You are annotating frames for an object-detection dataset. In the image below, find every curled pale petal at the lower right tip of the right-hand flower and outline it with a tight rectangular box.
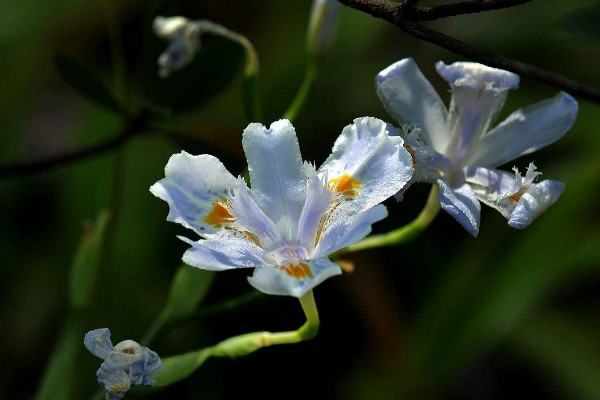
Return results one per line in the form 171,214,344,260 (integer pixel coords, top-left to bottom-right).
508,180,565,229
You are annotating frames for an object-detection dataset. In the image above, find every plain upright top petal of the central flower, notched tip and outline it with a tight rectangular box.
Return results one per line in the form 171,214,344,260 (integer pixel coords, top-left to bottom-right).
242,120,306,224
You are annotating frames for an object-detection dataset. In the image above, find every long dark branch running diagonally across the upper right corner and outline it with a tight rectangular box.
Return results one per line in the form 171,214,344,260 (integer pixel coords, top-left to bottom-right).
339,0,600,103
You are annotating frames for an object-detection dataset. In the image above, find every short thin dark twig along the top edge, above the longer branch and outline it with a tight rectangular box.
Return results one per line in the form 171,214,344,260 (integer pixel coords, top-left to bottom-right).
410,0,531,21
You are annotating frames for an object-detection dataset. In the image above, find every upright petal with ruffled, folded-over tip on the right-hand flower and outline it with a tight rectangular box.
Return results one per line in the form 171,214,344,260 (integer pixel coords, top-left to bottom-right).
435,61,519,165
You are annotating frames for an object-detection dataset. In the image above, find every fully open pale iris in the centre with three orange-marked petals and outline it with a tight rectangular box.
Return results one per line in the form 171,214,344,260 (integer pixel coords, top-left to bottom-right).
150,118,412,297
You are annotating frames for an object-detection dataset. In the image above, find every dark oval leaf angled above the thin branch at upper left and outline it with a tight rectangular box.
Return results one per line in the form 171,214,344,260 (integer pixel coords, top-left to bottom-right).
54,54,125,114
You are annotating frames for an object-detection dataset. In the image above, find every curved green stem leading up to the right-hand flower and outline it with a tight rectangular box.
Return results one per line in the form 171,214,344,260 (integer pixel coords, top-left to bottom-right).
334,185,440,257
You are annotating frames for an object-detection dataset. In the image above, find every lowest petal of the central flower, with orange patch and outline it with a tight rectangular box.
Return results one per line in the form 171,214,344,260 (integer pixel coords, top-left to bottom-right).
248,257,342,297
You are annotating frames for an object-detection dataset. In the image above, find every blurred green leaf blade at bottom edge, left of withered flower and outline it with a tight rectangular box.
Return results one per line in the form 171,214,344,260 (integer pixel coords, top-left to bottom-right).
36,317,83,400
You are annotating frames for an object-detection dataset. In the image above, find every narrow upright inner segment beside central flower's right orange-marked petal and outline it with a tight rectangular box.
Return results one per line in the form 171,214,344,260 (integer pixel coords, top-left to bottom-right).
298,176,335,251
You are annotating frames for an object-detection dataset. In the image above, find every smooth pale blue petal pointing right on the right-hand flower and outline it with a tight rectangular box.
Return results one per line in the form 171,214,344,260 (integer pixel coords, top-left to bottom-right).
466,92,578,167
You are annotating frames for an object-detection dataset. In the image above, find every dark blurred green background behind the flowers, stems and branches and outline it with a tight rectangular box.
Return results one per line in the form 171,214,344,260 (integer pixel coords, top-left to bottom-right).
0,0,600,400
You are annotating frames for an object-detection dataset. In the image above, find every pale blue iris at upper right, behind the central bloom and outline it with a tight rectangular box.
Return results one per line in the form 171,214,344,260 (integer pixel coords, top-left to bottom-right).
375,58,577,236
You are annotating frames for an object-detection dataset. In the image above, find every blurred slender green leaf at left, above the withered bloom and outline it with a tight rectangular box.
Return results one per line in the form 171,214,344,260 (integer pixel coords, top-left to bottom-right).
69,211,109,310
